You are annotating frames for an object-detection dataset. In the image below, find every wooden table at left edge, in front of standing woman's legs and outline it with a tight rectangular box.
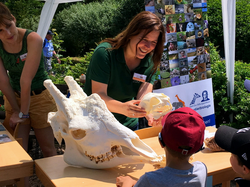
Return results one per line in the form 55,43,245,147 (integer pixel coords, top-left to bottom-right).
0,123,34,186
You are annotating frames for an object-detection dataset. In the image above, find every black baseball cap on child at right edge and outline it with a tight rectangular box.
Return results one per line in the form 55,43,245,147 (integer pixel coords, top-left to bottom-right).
215,125,250,169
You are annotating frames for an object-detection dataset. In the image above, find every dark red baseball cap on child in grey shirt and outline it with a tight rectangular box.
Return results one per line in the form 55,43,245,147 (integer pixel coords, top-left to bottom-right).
160,107,206,155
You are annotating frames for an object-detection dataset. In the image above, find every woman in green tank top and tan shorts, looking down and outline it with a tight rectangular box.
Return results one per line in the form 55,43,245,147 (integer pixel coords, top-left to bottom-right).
0,3,57,157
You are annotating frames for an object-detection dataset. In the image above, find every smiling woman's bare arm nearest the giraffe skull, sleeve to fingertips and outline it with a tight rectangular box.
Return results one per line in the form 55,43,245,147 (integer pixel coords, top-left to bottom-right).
91,80,146,118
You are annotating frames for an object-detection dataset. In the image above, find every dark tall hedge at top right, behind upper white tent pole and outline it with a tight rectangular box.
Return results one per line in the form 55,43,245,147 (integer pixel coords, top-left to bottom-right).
207,0,250,62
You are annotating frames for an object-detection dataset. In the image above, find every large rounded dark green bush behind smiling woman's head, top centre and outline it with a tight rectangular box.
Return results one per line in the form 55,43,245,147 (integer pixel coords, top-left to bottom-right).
53,0,144,56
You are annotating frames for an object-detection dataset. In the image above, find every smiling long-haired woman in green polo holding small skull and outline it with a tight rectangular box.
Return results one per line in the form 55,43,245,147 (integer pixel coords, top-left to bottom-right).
84,11,165,130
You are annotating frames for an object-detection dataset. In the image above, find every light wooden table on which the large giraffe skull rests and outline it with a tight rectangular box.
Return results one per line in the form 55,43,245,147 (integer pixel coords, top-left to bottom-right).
35,126,236,187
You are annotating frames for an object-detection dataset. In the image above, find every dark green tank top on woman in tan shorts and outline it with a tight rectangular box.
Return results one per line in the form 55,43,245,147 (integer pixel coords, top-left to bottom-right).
0,30,49,91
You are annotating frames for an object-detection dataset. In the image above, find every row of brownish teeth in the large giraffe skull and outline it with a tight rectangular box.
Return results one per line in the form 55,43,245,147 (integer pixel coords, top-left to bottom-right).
84,145,122,164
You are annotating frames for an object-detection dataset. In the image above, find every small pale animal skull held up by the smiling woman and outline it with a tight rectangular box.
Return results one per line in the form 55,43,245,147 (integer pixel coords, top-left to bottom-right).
139,92,173,119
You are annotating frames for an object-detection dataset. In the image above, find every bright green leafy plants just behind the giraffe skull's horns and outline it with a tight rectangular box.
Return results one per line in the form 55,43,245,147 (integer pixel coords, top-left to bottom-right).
50,49,94,84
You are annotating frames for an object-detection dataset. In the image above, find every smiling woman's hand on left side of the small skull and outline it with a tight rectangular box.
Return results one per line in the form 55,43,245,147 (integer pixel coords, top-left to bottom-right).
123,100,147,118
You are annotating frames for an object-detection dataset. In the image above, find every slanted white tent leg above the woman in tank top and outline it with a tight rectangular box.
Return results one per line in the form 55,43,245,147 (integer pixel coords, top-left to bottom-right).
37,0,82,39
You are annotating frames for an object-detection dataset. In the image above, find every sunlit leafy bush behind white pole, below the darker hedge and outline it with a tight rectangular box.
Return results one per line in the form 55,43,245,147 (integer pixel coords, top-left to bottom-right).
210,44,250,128
